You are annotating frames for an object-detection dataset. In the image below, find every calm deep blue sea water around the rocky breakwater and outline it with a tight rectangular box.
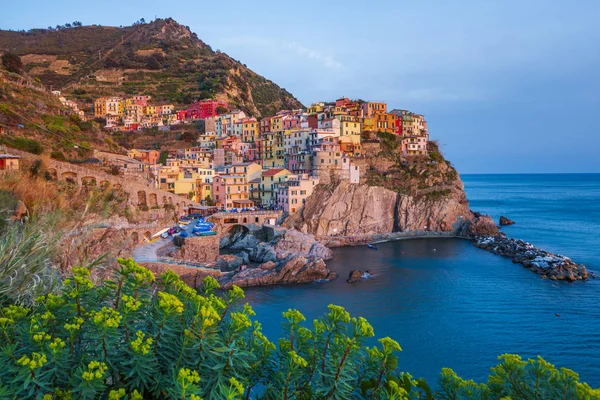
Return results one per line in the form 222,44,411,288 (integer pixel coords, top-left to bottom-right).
247,175,600,386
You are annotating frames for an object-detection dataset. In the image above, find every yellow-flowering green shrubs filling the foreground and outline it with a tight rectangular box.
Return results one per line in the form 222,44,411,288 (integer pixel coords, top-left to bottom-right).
0,255,600,400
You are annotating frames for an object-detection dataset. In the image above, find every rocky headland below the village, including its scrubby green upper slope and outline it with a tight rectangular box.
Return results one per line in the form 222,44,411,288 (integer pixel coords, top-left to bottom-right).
285,137,478,239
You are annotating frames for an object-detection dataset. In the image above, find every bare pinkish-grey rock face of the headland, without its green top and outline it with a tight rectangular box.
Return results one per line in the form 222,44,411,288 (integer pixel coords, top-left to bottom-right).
286,178,474,236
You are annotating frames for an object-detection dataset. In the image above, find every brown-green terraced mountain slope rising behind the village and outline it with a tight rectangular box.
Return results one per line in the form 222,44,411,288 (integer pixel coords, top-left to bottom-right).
0,18,302,116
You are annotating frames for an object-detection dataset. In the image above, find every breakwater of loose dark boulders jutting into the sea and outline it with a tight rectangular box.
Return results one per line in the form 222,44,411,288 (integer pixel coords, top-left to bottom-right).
474,233,596,282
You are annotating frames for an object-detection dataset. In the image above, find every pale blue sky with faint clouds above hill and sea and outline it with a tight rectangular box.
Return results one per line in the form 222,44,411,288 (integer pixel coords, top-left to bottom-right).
0,0,600,173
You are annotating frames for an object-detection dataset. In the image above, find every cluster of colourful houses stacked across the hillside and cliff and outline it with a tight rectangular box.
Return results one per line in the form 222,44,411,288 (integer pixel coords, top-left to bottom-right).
5,92,429,214
